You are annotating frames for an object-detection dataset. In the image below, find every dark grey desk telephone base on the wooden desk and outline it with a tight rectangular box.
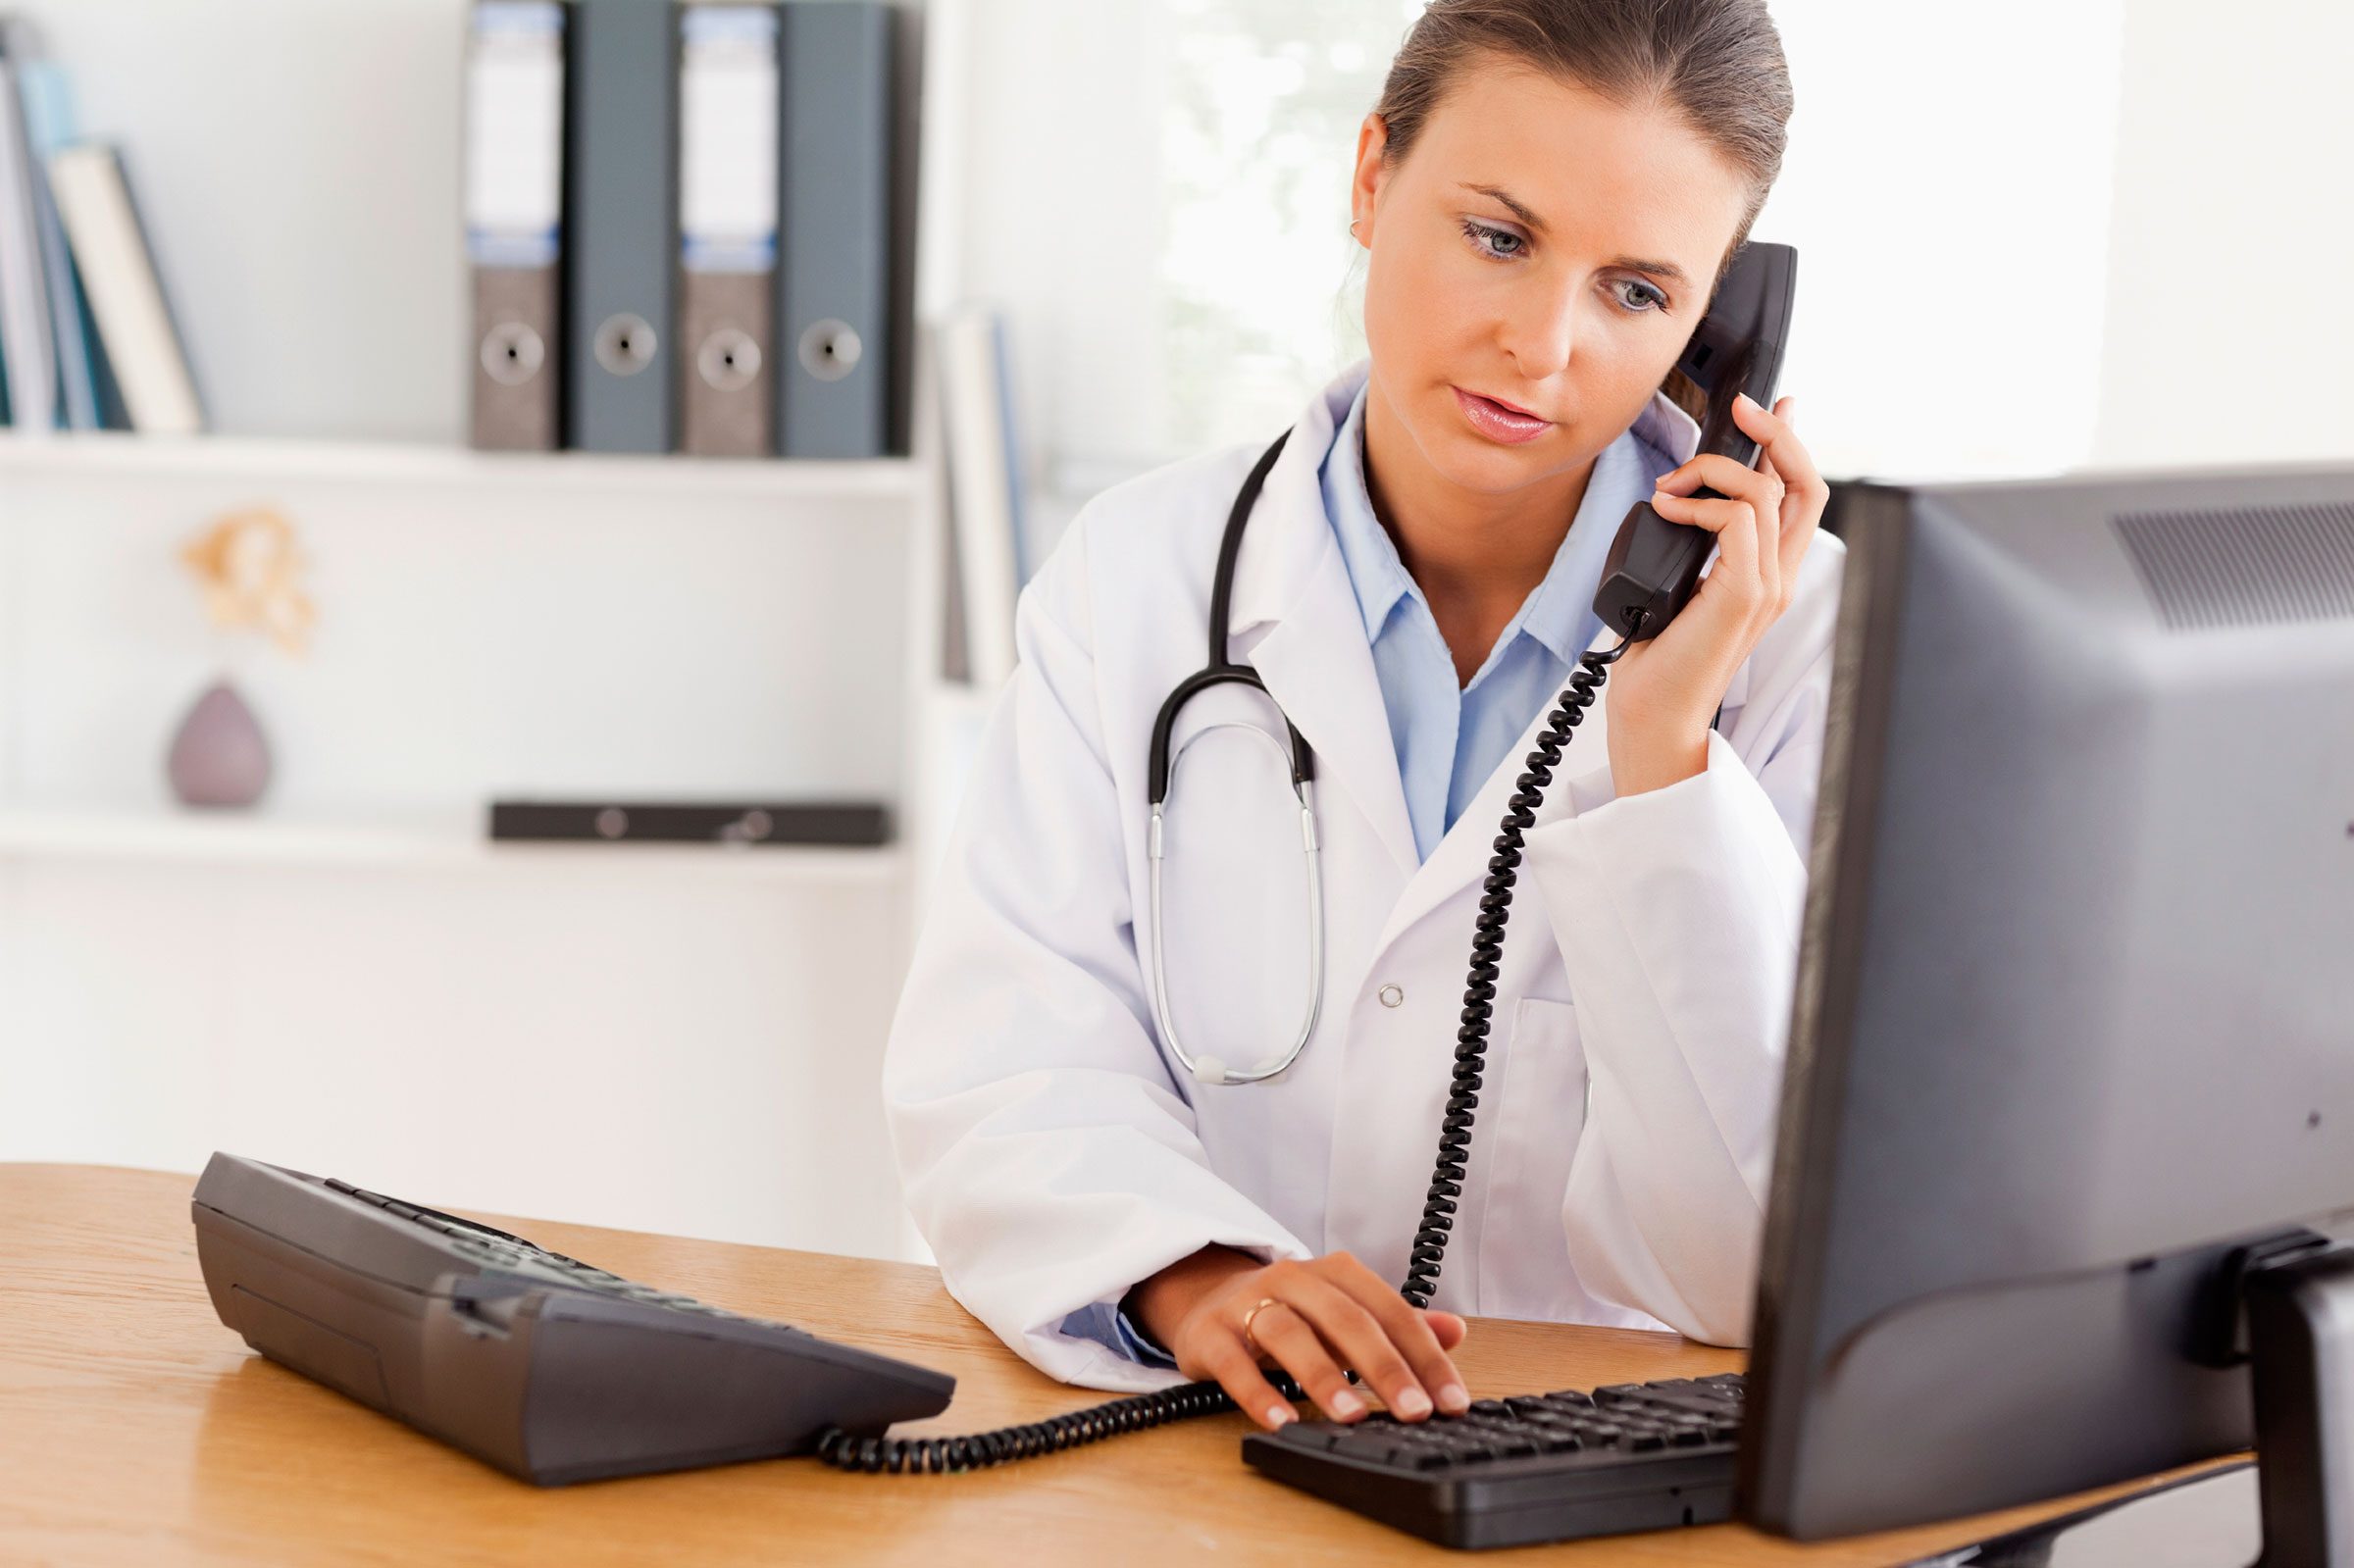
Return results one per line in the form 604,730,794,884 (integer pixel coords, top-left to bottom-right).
190,1153,955,1486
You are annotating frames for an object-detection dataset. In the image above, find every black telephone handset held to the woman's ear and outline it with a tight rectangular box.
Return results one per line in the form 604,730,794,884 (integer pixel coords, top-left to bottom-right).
1594,240,1799,642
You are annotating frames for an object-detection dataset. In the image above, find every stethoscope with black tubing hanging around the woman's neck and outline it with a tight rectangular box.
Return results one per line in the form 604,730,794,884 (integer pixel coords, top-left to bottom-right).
1144,429,1725,1086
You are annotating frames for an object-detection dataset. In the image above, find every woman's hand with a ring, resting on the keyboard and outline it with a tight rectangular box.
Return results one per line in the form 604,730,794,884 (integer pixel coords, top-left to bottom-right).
1135,1247,1471,1432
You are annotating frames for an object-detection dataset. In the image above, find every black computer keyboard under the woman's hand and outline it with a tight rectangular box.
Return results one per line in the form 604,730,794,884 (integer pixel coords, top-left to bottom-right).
1243,1373,1742,1546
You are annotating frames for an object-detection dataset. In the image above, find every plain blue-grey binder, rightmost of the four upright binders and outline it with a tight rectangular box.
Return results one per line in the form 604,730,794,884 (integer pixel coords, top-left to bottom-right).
775,0,895,457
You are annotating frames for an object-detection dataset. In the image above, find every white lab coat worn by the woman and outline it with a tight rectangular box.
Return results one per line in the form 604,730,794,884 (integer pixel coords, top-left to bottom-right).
883,360,1846,1391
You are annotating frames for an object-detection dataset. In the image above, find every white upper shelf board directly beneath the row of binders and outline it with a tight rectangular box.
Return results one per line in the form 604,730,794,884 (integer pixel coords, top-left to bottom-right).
0,430,923,501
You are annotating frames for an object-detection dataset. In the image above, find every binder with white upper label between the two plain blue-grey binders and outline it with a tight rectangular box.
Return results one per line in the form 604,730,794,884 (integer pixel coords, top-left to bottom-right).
678,0,779,457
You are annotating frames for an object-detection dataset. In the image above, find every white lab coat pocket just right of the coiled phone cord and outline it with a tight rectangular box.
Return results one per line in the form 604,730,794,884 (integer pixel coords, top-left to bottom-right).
1471,996,1587,1299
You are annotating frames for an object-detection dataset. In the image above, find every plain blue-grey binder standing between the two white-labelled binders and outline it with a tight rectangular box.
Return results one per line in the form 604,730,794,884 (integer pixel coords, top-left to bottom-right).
565,0,678,452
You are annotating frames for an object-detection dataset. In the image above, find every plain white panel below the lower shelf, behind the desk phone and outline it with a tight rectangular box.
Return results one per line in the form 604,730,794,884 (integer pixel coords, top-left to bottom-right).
0,847,911,1262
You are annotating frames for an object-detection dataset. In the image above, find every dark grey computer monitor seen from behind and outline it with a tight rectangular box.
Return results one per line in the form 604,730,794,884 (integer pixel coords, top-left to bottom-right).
1740,466,2354,1535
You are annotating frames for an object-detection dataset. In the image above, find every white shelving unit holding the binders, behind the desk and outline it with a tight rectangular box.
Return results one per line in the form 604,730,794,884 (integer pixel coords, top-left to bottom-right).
0,0,989,1257
